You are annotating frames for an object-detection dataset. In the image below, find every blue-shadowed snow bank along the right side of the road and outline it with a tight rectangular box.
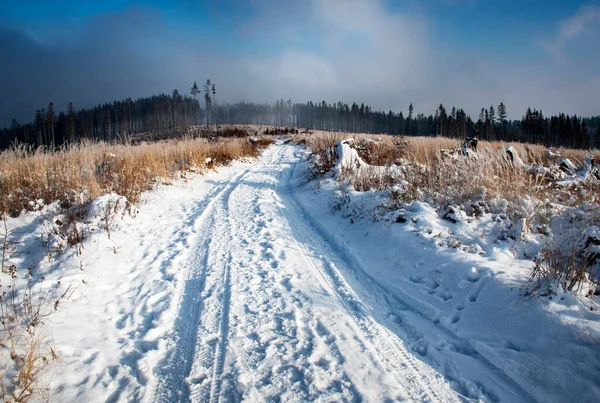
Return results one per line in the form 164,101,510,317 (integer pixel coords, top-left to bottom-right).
300,150,600,402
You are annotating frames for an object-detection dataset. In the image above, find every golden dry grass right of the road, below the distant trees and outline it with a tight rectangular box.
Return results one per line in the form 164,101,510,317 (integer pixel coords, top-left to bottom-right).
296,132,600,207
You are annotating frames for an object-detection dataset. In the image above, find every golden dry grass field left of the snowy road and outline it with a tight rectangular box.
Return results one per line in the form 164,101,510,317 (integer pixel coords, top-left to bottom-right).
0,138,271,216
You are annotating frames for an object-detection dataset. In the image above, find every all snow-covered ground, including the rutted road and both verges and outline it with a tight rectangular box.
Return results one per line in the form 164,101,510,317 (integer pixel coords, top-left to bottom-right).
1,142,600,402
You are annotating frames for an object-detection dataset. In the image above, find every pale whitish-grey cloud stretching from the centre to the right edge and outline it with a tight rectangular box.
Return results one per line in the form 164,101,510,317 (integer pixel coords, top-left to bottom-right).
234,0,600,118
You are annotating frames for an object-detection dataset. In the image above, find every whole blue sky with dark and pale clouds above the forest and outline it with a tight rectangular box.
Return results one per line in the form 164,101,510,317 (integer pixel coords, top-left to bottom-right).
0,0,600,126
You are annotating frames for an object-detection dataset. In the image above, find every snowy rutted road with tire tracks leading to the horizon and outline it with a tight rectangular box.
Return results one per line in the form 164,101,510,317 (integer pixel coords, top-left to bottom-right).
145,145,460,402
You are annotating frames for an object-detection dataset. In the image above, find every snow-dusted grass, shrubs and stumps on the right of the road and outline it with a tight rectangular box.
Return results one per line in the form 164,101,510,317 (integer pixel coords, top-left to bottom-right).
308,134,600,295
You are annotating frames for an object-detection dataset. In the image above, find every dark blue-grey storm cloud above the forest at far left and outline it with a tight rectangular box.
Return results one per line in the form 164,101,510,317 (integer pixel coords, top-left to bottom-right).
0,10,176,125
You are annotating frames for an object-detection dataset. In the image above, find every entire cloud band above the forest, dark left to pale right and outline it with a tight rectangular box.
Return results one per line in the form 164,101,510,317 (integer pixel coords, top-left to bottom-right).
0,0,600,125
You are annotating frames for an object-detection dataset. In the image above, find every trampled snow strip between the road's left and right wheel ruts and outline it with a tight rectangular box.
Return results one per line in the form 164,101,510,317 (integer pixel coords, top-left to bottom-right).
224,147,364,401
